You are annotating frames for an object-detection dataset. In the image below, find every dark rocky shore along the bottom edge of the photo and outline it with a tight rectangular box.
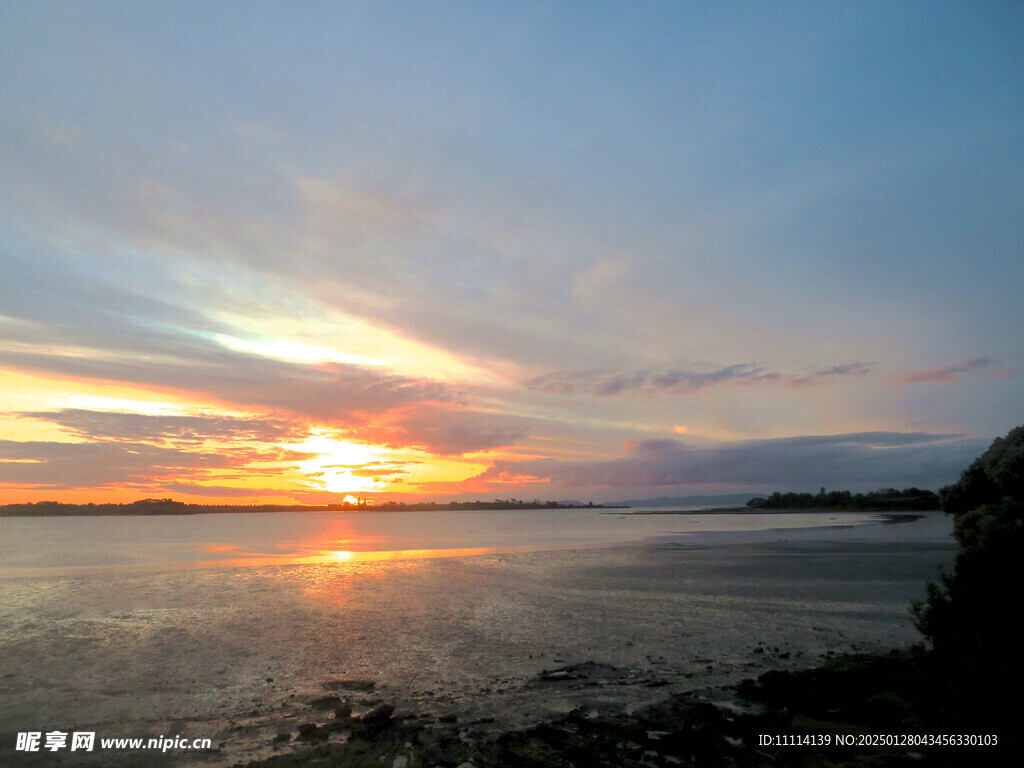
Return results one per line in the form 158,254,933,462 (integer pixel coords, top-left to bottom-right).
230,650,991,768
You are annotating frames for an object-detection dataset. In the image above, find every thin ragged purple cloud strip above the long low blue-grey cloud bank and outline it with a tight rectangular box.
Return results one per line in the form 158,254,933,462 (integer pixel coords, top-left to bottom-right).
524,362,876,397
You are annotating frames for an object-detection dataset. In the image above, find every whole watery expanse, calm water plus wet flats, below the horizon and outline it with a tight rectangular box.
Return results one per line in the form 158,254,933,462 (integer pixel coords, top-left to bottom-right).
0,510,954,768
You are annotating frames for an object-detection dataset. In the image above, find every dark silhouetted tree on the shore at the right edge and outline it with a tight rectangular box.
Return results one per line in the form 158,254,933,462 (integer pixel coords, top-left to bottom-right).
914,426,1024,735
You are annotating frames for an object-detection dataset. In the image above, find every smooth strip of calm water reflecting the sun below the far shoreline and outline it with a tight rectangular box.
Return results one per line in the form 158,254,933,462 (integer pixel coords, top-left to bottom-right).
0,509,878,575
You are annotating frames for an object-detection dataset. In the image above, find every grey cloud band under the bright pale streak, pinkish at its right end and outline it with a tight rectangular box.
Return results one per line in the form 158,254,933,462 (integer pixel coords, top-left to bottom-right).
0,243,457,423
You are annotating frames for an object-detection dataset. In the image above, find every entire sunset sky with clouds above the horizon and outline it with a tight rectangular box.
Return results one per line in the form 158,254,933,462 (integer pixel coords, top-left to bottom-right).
0,0,1024,504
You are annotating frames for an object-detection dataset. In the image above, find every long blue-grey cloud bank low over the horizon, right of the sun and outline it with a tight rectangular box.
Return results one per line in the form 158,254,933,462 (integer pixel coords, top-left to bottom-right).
464,432,984,490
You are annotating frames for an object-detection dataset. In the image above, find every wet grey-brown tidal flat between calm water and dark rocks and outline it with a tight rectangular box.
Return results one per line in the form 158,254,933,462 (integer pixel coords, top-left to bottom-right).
0,514,954,765
